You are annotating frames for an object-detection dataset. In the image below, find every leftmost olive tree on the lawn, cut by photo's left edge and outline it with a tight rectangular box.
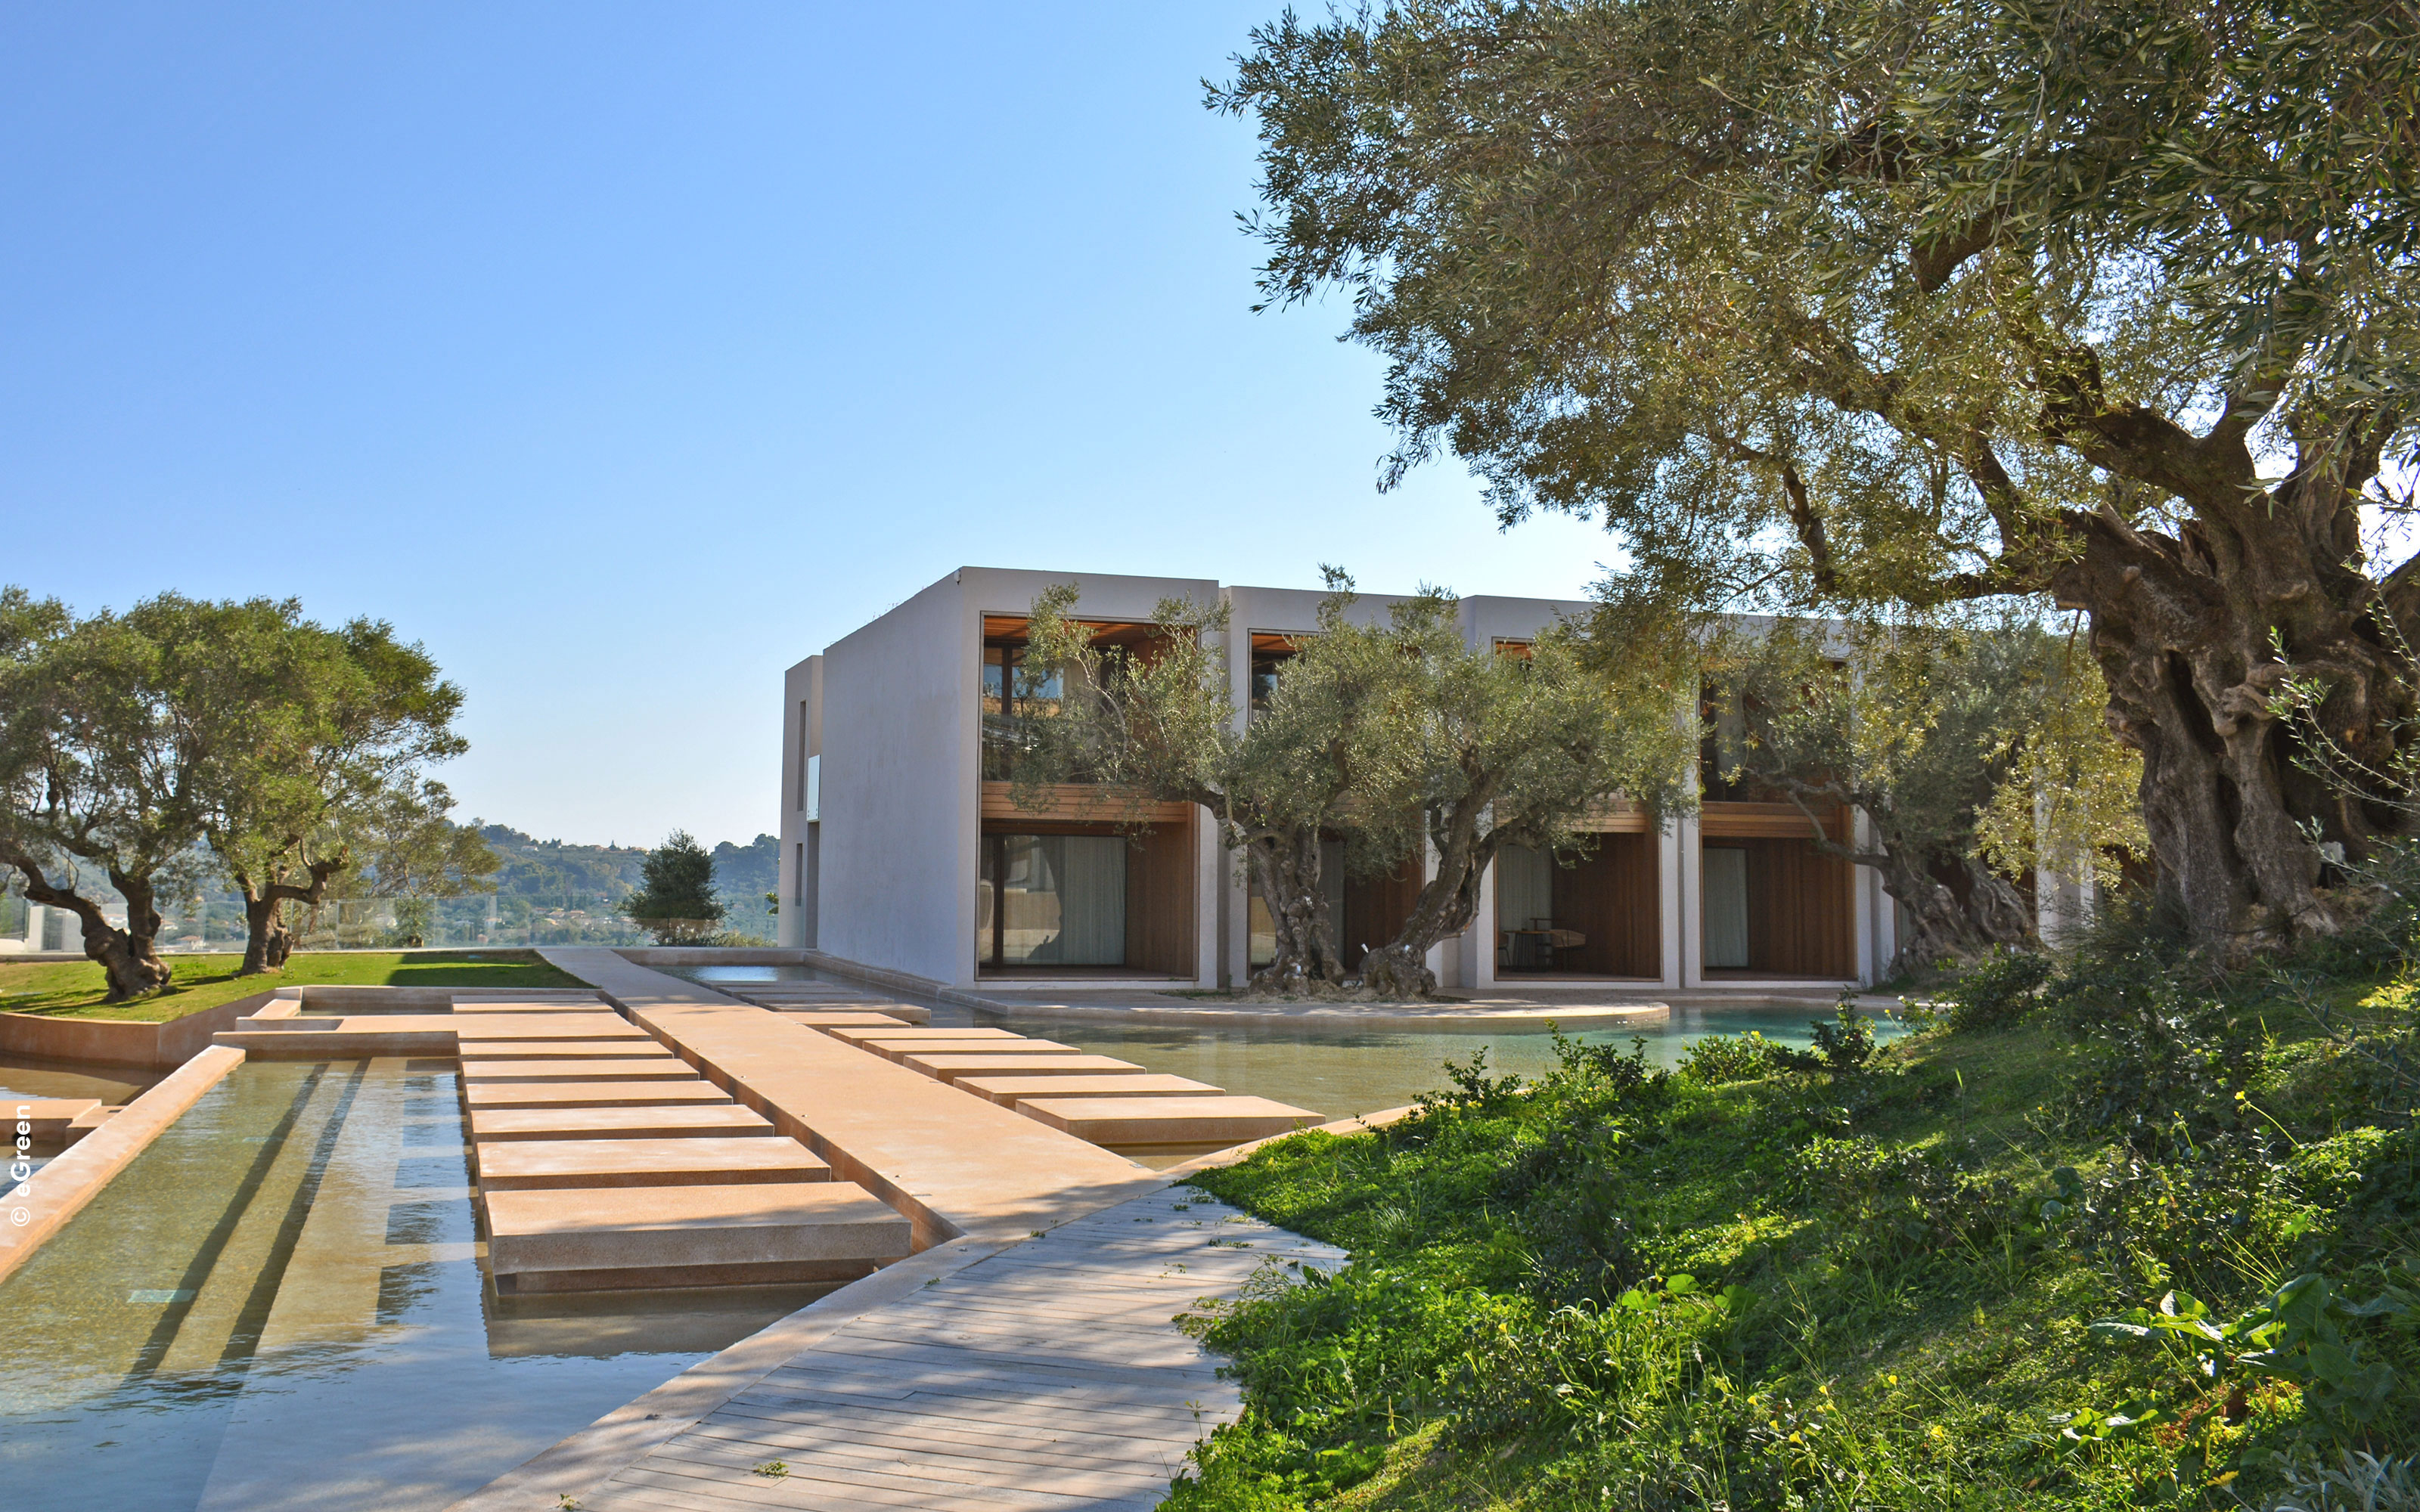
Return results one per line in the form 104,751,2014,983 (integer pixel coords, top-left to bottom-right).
0,588,250,1002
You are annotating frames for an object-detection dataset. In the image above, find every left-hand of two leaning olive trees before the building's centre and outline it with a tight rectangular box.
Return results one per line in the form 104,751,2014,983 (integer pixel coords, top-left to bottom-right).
1012,569,1401,994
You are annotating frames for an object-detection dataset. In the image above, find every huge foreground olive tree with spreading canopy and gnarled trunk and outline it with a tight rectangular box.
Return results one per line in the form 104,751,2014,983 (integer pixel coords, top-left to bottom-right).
1212,0,2420,958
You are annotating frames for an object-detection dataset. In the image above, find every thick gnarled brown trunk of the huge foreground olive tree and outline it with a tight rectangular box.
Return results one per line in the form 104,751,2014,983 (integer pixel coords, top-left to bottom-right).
2049,404,2420,963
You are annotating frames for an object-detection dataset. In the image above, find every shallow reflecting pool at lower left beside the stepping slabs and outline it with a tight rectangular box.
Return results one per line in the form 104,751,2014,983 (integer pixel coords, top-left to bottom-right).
0,1057,818,1512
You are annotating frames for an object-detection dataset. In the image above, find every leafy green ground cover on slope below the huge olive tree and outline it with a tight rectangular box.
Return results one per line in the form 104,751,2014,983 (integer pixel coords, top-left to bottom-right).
1169,914,2420,1512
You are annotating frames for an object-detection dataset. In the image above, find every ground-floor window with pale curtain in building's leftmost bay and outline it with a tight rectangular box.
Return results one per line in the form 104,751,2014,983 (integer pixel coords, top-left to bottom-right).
976,835,1128,970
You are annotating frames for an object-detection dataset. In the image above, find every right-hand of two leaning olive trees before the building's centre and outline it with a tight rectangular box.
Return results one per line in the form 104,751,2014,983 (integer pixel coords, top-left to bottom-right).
1339,588,1692,996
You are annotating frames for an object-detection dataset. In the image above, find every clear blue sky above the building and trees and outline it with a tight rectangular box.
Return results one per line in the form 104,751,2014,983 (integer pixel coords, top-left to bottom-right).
0,0,1612,844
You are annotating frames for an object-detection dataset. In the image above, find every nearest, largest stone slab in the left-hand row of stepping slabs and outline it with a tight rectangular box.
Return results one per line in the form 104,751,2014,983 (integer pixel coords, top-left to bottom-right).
486,1181,910,1294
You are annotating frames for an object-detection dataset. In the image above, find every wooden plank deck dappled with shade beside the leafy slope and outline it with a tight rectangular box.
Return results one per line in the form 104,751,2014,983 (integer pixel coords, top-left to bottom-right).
576,1185,1343,1512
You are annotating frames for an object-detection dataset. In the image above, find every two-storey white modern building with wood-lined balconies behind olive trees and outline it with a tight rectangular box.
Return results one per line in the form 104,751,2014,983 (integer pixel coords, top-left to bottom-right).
779,566,1895,992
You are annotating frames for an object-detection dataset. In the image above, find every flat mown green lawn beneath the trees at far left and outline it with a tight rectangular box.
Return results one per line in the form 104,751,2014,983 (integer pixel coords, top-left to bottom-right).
0,951,585,1024
